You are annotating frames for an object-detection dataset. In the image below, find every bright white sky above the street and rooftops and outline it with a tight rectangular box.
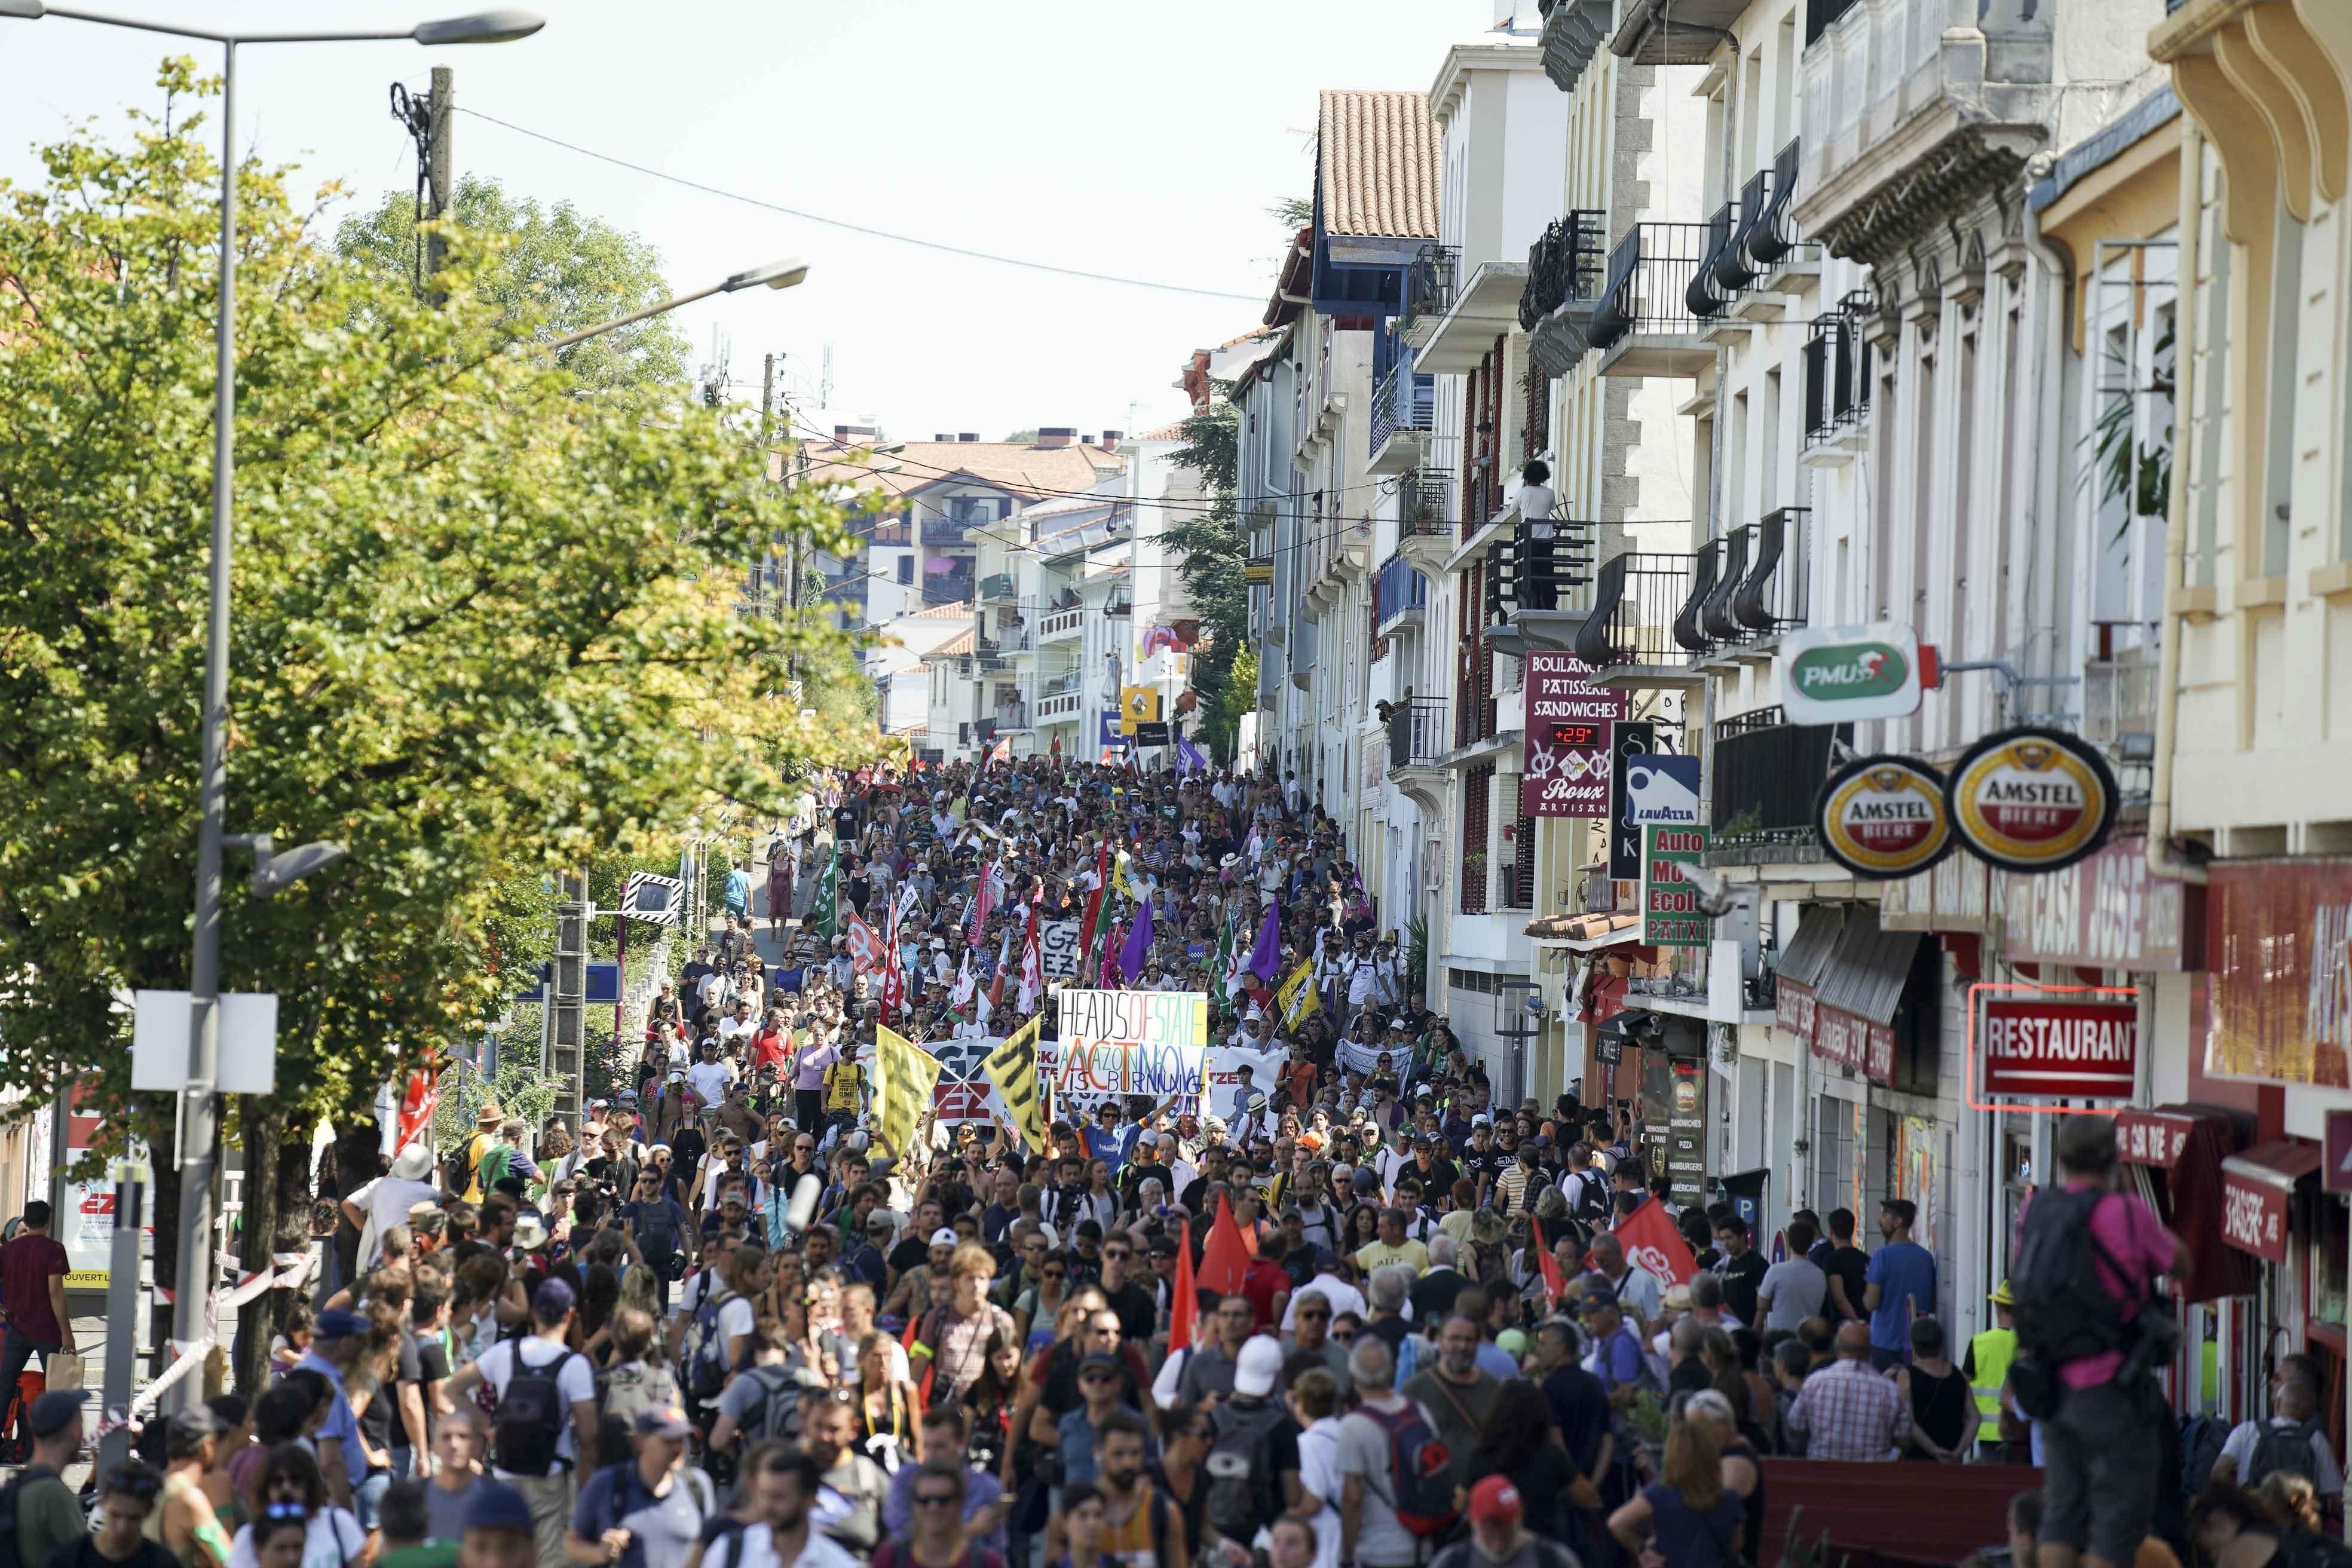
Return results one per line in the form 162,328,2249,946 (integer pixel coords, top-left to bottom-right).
0,0,1493,440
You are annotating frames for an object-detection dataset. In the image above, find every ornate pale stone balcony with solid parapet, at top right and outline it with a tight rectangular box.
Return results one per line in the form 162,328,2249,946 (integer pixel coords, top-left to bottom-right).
1792,0,2060,261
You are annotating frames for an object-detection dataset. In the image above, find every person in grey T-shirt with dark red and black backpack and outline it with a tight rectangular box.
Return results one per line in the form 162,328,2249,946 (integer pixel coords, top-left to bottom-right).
1339,1336,1456,1568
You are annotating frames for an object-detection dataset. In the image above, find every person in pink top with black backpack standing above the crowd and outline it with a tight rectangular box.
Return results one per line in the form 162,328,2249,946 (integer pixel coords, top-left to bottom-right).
2011,1117,2187,1568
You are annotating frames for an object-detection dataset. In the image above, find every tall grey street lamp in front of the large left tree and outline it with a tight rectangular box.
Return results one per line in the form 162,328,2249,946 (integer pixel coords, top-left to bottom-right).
0,0,546,1408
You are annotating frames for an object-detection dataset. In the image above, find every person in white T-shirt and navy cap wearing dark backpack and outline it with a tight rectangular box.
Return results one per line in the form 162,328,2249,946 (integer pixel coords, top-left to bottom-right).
449,1279,598,1568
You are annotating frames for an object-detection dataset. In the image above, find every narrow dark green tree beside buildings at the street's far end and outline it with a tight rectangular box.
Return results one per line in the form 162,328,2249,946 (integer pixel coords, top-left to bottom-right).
1166,383,1256,757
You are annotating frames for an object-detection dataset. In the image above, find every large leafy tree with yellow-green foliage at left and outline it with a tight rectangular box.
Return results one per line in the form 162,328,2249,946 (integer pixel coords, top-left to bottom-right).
0,61,880,1380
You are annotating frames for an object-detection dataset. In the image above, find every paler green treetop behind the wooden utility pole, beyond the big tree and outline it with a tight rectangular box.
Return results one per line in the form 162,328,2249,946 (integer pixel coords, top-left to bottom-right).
334,174,687,390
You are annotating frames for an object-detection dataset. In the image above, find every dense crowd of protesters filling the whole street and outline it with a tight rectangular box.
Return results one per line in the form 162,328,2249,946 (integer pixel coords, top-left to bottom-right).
0,760,2340,1568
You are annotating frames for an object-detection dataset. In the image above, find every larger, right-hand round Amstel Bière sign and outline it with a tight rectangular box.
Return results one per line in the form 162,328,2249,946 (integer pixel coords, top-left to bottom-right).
1945,729,2114,874
